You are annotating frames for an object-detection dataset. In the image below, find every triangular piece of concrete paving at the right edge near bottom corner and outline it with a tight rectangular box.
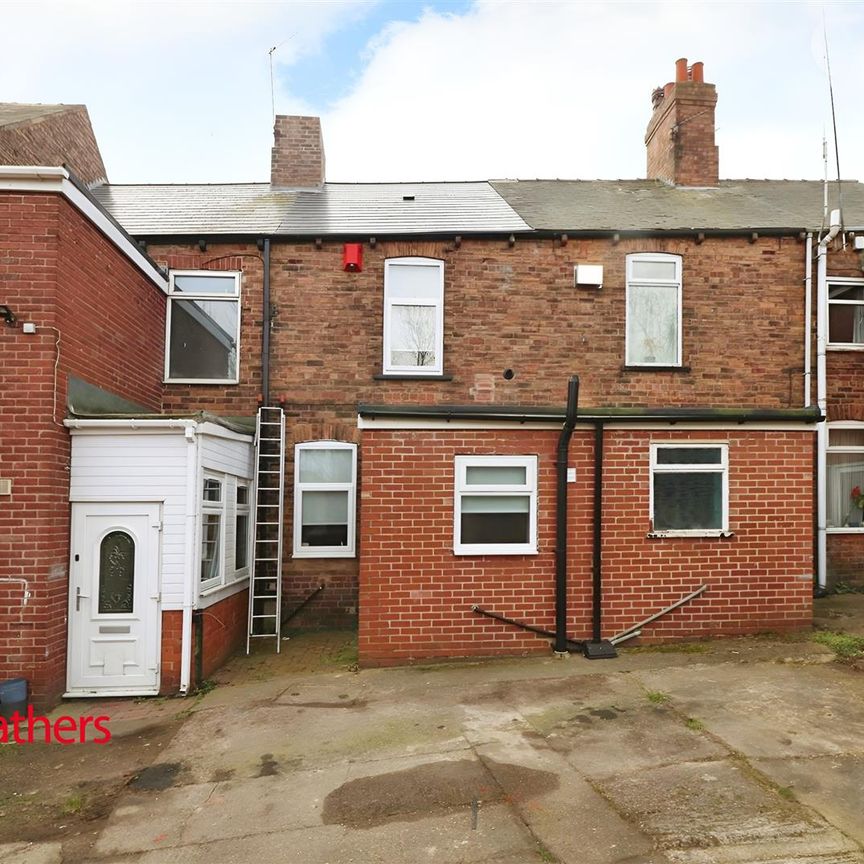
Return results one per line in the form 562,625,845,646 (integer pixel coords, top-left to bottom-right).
753,756,864,846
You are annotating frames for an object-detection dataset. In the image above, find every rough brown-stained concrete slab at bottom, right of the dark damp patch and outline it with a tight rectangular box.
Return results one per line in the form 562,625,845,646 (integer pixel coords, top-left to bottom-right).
600,760,860,864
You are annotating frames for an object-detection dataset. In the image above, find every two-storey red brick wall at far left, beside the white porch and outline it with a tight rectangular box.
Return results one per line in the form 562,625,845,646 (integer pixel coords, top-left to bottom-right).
0,193,164,704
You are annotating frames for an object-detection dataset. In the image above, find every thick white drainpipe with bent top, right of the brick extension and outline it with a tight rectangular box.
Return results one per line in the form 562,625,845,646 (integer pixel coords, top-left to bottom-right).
816,210,840,588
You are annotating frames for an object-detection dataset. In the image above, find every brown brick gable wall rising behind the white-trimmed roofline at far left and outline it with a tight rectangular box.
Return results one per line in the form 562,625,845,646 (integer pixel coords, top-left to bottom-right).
0,105,105,185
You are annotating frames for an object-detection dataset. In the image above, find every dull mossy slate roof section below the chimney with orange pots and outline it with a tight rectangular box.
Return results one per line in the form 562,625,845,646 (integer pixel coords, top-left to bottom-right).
492,180,864,232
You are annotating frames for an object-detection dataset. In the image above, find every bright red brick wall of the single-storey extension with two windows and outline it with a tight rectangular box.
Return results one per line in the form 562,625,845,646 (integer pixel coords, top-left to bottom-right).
360,427,813,663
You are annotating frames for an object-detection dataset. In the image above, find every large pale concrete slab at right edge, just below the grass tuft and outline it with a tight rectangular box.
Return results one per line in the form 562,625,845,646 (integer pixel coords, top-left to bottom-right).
639,663,864,758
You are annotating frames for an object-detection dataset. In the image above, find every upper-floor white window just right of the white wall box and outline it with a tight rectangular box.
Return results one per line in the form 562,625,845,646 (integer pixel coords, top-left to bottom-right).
625,252,681,366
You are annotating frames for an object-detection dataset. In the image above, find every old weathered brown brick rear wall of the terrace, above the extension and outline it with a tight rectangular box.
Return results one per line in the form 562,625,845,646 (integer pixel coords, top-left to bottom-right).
142,231,804,626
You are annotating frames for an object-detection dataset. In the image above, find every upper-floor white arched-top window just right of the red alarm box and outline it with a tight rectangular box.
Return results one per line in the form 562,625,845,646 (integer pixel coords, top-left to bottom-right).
383,258,444,375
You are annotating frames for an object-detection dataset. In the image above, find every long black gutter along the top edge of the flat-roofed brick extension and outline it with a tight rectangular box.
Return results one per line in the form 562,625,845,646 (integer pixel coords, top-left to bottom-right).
357,403,825,425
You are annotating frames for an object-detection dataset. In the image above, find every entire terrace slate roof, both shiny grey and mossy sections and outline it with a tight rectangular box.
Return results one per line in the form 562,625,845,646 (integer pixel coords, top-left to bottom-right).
92,180,864,237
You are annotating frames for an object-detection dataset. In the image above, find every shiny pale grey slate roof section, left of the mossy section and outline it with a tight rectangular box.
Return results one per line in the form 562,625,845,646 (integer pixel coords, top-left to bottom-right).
92,182,530,237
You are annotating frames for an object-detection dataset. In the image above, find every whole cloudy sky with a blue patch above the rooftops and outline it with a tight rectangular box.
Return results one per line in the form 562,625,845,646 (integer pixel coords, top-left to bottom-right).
0,0,864,183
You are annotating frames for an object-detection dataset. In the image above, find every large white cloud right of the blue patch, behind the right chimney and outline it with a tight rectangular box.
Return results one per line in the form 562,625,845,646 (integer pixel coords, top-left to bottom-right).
324,0,864,180
